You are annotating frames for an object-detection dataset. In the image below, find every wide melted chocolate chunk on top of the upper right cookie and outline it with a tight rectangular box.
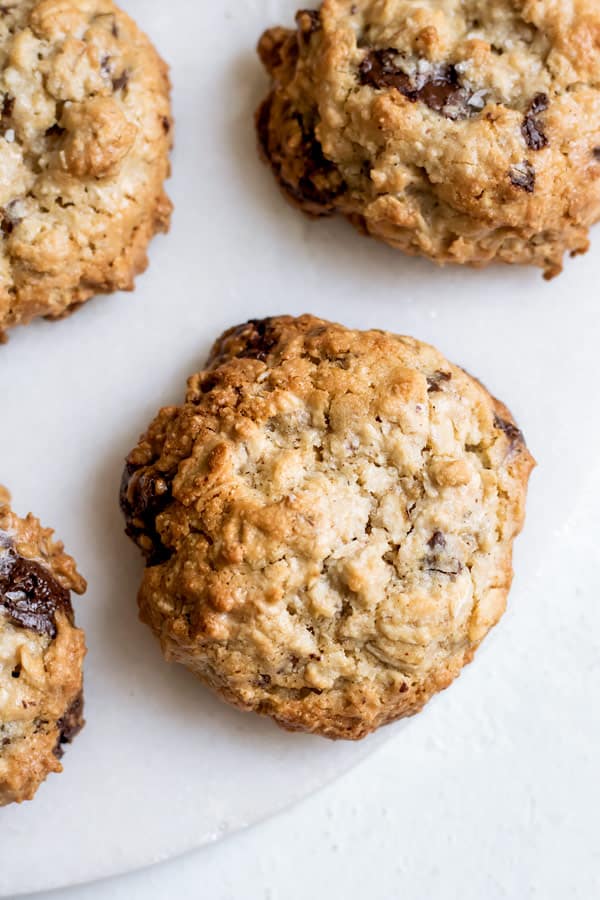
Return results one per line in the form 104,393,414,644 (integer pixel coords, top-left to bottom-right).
358,48,478,119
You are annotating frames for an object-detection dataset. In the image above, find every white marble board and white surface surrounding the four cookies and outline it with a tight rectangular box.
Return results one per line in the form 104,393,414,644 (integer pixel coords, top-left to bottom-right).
0,0,600,900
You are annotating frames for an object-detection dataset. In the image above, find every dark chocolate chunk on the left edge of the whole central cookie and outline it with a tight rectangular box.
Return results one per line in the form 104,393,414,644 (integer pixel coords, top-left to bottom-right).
120,462,172,566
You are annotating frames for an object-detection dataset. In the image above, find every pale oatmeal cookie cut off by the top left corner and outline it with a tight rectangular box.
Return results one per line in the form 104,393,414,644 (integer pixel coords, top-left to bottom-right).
0,0,172,336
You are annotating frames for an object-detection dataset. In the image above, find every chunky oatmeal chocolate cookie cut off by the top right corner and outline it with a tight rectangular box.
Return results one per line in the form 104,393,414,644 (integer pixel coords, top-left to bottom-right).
256,0,600,277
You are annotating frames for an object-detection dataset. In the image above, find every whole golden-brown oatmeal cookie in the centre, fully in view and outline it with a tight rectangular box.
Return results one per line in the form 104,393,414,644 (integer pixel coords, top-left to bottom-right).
121,316,533,739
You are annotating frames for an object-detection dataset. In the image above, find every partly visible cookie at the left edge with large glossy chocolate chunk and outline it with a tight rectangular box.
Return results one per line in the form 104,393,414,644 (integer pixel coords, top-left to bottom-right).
0,487,86,806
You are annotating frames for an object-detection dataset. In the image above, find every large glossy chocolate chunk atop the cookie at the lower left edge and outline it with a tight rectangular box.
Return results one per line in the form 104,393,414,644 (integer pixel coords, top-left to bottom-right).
0,547,73,638
